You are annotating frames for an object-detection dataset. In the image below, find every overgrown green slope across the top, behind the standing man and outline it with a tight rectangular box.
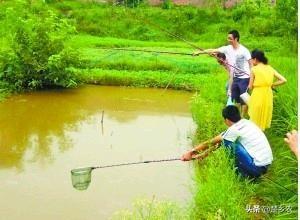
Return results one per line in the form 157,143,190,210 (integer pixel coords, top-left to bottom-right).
48,0,297,46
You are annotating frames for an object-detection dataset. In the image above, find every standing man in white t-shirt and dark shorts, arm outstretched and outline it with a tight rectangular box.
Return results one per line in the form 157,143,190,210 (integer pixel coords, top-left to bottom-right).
194,30,252,116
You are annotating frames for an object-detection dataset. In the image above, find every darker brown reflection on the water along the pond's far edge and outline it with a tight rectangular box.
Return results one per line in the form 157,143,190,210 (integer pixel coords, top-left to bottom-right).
0,86,189,170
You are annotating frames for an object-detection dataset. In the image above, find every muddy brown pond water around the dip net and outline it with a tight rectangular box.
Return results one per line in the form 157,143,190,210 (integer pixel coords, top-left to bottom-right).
0,86,193,220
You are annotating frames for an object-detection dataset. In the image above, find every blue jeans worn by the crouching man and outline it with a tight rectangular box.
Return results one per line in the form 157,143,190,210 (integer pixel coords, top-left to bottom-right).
223,140,268,179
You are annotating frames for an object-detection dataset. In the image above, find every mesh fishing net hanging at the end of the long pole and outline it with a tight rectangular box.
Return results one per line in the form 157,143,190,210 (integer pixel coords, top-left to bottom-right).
71,167,92,190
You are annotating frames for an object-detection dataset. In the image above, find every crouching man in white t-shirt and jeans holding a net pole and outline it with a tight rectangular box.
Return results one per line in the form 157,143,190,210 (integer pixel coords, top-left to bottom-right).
181,105,273,178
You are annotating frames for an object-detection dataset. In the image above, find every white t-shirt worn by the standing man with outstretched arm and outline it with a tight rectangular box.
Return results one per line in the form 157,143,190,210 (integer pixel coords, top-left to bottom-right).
218,44,251,79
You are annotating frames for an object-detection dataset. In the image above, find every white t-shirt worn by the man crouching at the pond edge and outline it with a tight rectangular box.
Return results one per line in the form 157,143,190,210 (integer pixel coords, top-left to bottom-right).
221,119,273,166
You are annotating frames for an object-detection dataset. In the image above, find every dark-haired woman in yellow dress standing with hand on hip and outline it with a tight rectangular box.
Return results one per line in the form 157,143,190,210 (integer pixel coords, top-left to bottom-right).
248,49,286,131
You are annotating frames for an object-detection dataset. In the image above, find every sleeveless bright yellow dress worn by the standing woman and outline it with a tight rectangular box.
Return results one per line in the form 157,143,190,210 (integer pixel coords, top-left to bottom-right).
248,63,275,131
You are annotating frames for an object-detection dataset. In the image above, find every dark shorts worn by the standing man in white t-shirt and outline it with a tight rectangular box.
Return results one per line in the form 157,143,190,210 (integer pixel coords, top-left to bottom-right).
231,78,250,105
